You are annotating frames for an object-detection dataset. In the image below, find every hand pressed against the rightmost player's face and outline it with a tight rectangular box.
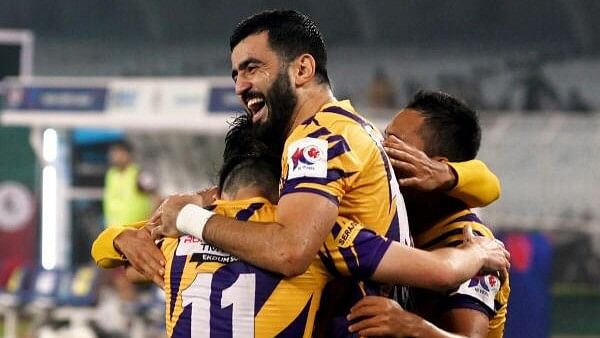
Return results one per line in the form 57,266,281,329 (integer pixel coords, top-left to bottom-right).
383,135,457,191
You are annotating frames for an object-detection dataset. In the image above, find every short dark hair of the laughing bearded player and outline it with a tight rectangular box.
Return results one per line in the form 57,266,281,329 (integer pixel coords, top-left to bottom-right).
229,10,329,84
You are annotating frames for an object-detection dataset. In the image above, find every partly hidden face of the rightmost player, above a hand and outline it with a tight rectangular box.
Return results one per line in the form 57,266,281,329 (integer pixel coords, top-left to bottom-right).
385,108,425,151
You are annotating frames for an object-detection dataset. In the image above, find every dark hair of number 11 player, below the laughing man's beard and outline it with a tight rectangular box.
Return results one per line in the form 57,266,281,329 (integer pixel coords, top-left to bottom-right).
219,114,281,203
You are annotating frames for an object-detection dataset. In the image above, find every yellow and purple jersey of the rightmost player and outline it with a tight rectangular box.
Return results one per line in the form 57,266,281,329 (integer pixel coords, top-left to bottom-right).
415,209,510,338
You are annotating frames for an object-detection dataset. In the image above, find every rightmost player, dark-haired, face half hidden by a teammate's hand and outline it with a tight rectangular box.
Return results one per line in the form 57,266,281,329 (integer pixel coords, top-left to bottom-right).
350,91,510,338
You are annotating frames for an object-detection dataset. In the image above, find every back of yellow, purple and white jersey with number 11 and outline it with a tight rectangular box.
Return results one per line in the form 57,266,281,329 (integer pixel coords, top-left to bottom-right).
161,198,327,338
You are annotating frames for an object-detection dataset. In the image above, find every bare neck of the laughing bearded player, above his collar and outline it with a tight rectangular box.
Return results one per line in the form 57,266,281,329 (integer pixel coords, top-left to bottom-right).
290,84,335,132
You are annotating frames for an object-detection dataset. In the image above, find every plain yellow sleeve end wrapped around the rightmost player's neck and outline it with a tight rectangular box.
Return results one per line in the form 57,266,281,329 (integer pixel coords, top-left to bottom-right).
448,160,500,208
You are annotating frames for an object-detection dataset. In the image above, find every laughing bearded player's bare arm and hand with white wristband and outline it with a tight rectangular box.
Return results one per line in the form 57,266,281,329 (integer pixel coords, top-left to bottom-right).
155,192,338,276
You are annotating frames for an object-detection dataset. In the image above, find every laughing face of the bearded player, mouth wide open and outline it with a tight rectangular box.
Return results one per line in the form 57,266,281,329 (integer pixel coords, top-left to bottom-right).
231,32,295,125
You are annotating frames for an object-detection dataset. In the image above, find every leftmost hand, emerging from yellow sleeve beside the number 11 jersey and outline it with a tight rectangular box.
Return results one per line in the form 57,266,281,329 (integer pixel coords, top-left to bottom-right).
113,227,165,288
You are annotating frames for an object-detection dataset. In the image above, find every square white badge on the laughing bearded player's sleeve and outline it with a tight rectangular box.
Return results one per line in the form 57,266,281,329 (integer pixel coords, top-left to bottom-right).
287,137,328,179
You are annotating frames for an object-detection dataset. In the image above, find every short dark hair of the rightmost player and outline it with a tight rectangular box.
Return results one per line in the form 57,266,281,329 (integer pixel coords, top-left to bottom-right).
406,90,481,162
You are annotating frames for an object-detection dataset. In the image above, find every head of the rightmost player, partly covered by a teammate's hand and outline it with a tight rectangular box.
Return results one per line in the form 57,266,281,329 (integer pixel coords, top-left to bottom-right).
386,91,481,162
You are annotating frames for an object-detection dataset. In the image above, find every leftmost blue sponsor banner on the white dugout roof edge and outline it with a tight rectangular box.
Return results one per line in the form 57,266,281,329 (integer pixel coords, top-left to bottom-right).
6,86,106,112
